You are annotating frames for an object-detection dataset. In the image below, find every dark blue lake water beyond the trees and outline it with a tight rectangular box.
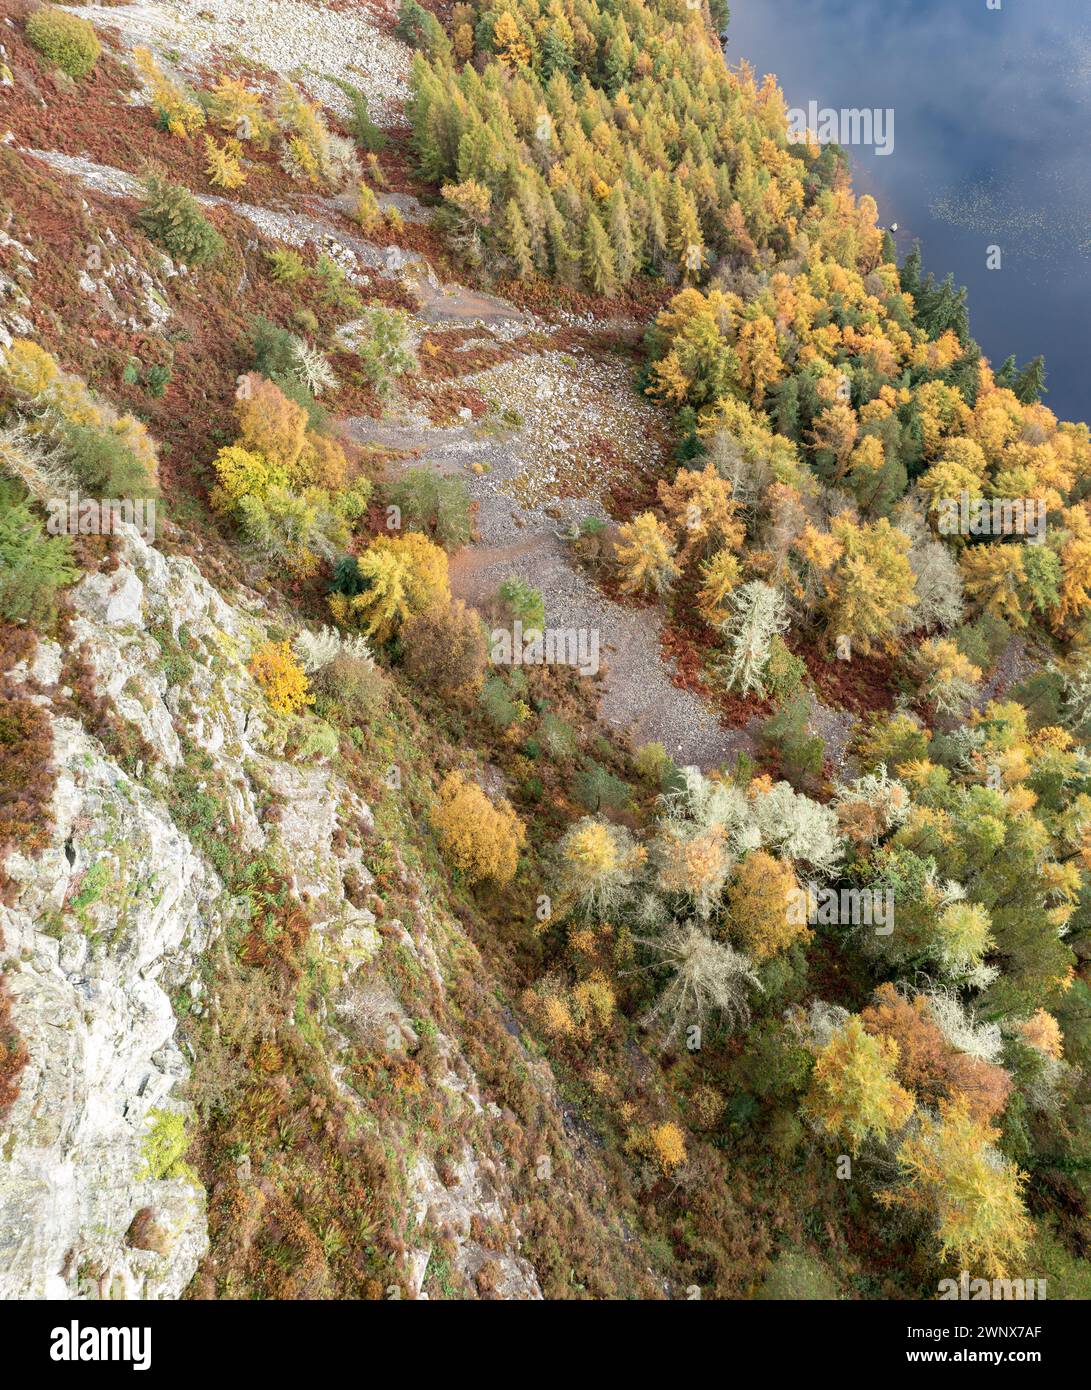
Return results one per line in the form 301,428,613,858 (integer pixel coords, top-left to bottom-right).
727,0,1091,420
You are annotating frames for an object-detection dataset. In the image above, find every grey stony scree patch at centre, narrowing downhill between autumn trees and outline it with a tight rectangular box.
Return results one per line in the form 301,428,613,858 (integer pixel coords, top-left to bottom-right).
345,344,749,771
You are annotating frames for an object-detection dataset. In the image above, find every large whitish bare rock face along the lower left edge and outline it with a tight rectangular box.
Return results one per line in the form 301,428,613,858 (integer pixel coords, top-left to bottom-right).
0,706,221,1298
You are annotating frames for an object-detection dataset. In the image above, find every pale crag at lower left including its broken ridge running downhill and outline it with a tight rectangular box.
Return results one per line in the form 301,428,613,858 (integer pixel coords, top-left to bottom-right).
0,528,541,1298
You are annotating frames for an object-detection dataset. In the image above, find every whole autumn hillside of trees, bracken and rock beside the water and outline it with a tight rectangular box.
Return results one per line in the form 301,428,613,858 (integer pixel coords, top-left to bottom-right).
0,0,1091,1300
